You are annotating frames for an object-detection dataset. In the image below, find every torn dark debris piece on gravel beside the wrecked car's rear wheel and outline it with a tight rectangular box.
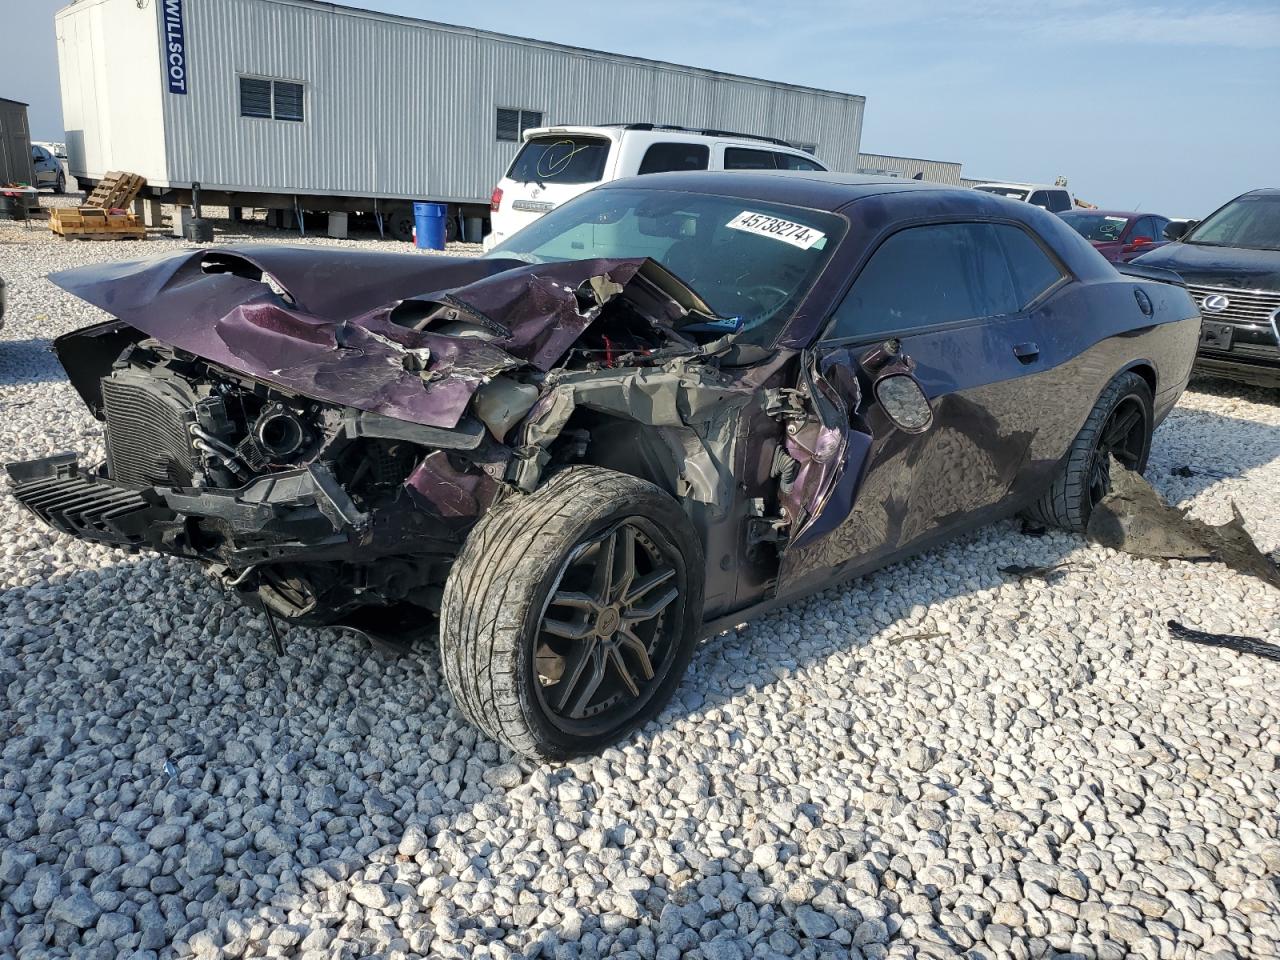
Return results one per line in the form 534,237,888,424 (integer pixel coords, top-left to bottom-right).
1087,458,1280,589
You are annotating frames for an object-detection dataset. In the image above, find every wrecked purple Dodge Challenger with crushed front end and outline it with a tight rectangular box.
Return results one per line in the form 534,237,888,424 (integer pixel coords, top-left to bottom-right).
8,173,1199,759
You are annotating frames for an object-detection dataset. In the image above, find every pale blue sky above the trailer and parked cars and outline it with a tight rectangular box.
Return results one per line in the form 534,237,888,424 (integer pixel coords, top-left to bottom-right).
0,0,1280,218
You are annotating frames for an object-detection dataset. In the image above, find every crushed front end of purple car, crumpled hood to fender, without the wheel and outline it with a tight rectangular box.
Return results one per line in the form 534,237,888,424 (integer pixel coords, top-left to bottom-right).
24,251,778,640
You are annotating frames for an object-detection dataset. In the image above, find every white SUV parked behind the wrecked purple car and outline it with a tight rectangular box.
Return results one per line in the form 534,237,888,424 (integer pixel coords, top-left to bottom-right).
484,123,827,250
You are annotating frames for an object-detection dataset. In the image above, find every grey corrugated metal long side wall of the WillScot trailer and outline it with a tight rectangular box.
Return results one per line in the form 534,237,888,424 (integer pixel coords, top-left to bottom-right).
156,0,864,201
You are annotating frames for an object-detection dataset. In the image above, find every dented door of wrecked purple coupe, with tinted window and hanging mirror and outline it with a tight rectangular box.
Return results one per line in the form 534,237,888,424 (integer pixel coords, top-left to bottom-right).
780,223,1069,589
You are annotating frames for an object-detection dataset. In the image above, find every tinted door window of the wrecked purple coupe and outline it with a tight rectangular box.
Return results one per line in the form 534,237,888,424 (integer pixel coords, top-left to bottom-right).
827,223,1019,339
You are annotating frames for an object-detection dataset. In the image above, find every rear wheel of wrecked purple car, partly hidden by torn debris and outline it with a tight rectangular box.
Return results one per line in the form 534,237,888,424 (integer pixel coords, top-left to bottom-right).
1027,371,1156,534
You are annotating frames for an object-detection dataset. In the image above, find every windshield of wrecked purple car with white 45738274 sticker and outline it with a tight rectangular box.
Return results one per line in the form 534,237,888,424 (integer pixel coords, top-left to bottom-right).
486,188,845,346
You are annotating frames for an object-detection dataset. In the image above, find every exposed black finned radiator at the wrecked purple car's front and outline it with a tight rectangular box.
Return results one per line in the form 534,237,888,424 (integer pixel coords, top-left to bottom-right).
102,370,197,486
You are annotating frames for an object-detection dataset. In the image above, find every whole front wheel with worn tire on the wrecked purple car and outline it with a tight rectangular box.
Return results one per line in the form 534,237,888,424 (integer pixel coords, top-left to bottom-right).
440,467,703,760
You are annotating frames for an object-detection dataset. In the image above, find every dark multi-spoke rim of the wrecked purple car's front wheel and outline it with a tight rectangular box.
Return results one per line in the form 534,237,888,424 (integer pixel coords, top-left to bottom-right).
535,521,680,721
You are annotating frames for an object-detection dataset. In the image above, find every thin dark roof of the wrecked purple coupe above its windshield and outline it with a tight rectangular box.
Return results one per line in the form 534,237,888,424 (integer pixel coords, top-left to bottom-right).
596,170,957,211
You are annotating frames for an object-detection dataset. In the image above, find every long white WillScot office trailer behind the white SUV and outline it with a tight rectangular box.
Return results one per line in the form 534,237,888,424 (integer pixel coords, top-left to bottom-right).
55,0,865,236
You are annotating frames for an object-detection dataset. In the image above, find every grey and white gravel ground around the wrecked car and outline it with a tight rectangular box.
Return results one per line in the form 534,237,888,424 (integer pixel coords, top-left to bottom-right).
0,199,1280,960
